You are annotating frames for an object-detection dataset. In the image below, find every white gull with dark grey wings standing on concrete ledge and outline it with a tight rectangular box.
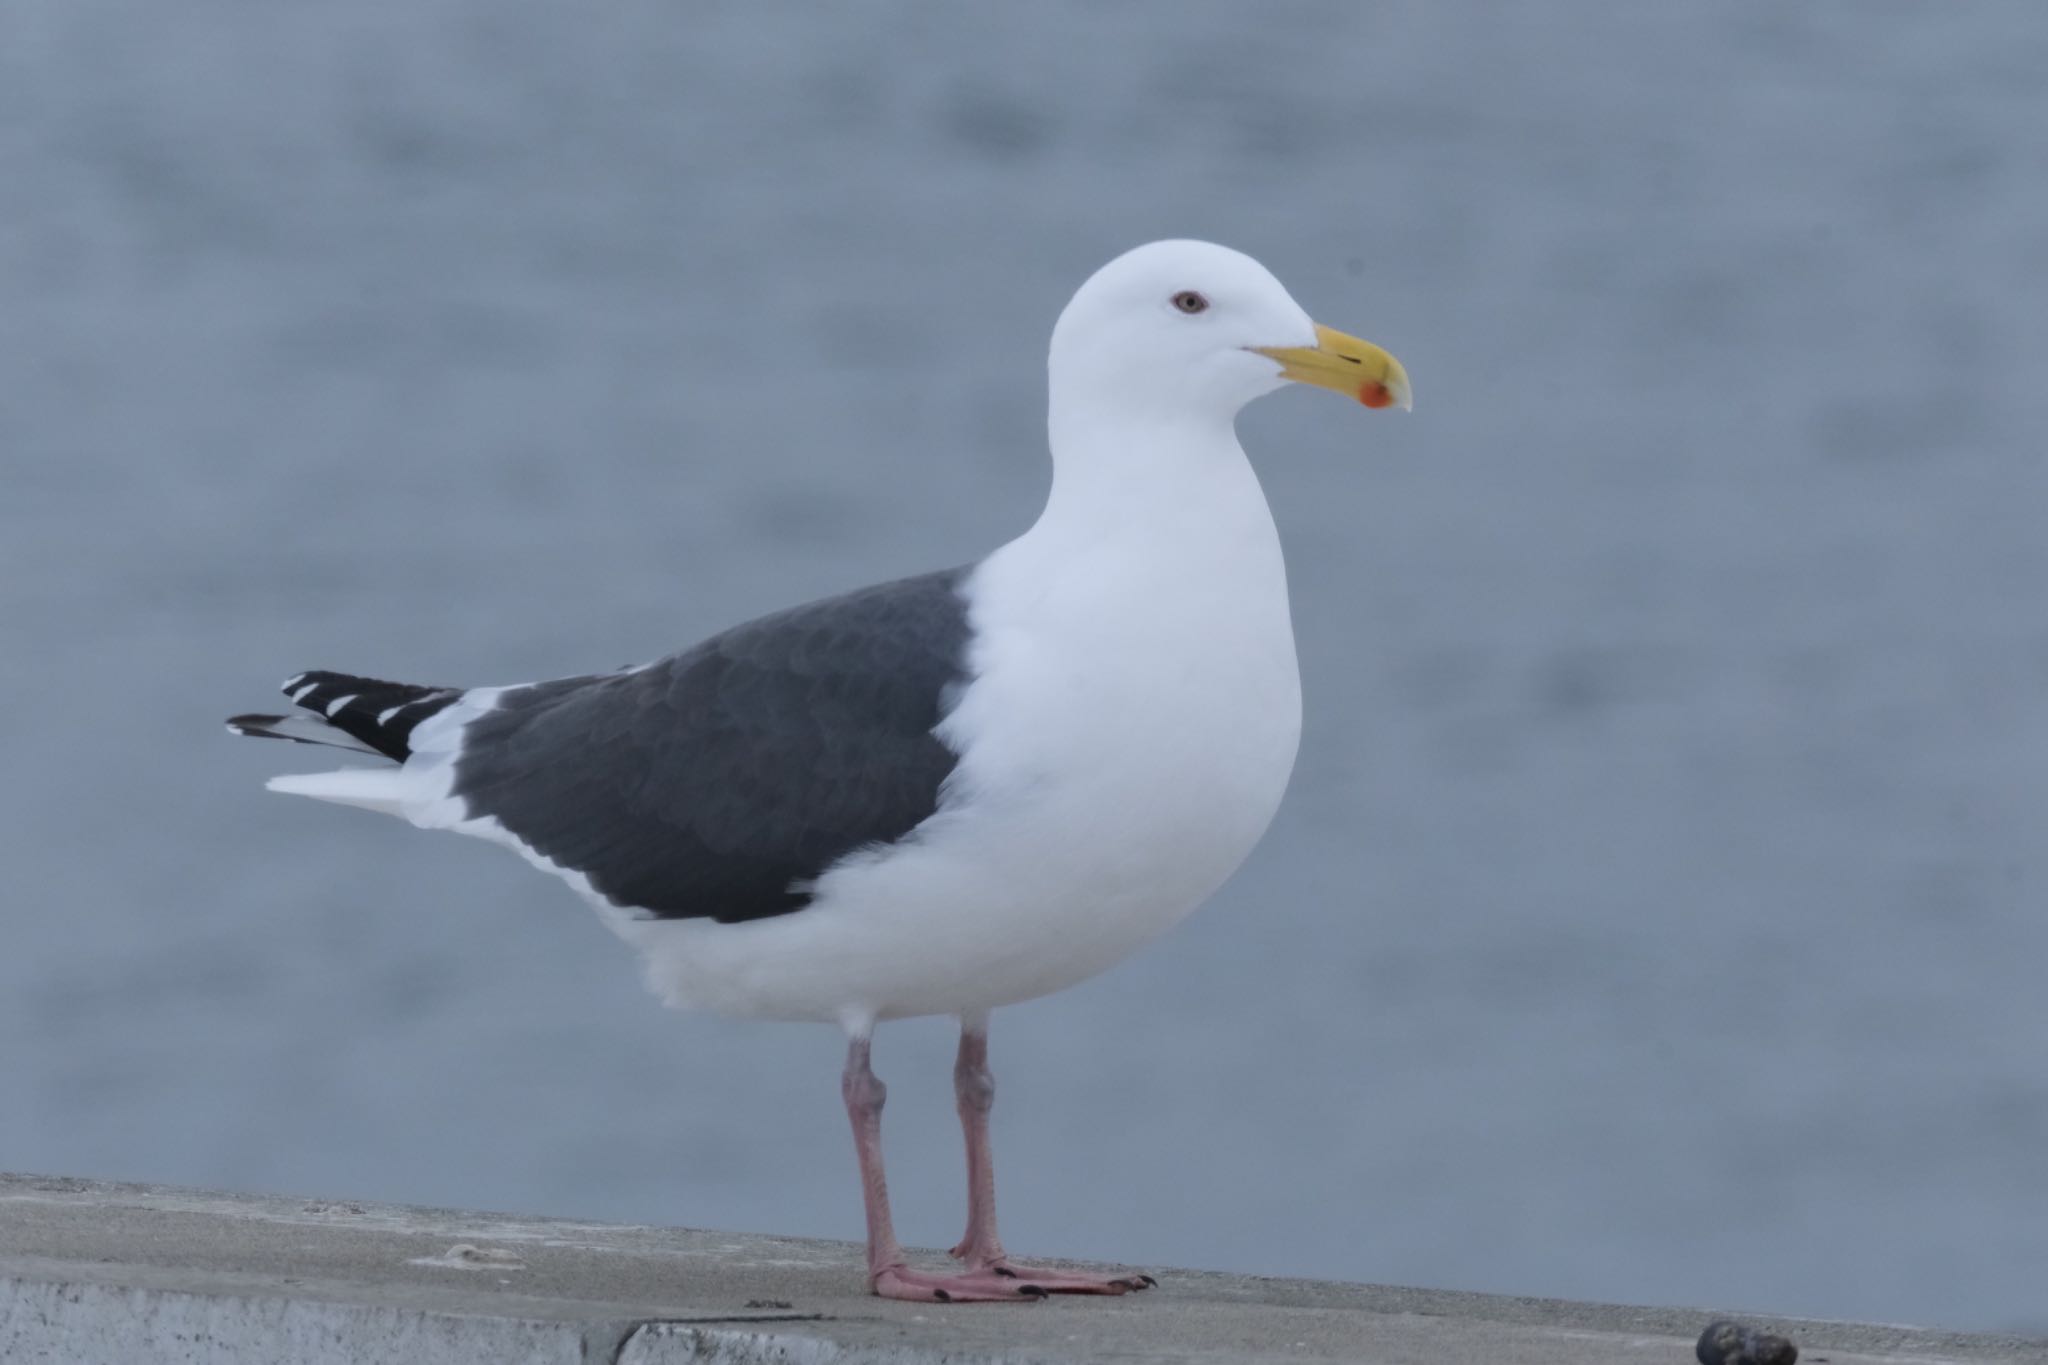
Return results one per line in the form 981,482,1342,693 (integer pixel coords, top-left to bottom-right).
227,241,1409,1304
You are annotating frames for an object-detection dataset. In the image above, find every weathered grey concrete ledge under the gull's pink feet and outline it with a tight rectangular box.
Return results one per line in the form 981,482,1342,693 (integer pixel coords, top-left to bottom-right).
0,1177,2048,1365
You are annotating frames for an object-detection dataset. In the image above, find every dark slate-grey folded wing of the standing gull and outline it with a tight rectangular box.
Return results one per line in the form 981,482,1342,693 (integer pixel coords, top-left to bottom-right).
455,571,969,923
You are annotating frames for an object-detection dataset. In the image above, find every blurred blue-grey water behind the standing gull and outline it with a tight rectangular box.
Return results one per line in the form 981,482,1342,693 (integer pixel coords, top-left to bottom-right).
0,0,2048,1330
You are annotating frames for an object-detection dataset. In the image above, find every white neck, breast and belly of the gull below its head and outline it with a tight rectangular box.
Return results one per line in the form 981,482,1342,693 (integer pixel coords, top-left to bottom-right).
621,430,1300,1019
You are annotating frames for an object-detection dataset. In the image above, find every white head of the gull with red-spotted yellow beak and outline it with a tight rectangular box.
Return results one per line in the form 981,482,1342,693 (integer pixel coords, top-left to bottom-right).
1049,241,1409,420
